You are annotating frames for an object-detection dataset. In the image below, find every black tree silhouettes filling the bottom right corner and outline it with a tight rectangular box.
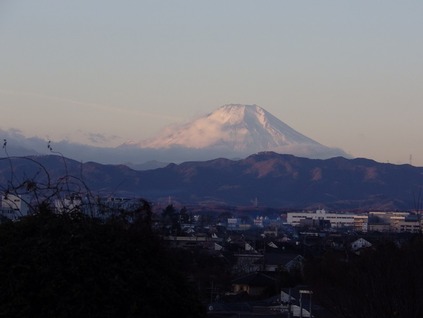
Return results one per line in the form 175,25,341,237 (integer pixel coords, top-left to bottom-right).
306,235,423,318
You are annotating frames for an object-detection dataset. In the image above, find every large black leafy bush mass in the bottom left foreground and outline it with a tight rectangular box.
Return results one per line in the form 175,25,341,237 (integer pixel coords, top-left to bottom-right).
0,202,205,317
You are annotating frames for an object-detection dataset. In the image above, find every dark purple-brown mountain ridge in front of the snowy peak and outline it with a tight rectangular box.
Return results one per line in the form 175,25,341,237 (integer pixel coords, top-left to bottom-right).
0,152,423,210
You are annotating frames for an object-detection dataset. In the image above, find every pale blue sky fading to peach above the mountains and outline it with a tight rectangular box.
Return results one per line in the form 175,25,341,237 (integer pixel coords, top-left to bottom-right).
0,0,423,166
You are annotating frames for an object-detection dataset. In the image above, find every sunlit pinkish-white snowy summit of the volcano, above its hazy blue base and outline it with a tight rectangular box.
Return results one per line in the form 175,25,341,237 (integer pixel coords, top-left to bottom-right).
138,104,316,153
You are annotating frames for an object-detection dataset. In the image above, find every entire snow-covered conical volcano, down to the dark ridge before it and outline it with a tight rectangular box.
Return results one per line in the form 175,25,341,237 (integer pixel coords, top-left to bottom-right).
120,104,350,161
